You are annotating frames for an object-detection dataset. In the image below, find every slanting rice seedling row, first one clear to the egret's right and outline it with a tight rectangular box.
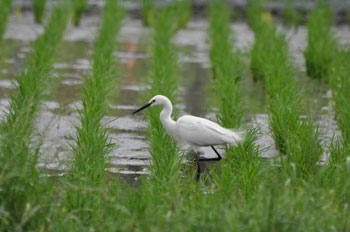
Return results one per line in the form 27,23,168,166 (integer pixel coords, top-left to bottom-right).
251,6,322,176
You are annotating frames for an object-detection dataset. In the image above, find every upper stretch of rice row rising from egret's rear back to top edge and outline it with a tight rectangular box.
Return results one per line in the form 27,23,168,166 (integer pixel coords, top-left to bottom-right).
209,1,245,128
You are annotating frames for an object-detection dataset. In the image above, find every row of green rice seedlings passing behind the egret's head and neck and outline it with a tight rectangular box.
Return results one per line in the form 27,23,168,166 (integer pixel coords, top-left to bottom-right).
147,5,180,181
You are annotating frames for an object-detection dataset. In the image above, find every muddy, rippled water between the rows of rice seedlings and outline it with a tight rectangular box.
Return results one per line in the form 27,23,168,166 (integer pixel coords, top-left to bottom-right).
0,12,350,179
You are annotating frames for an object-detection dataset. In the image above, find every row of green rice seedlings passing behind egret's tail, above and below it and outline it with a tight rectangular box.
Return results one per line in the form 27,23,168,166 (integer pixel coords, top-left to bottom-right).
209,1,259,195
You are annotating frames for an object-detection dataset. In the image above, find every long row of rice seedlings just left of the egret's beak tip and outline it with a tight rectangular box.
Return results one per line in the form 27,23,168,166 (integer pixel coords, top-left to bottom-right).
65,0,124,225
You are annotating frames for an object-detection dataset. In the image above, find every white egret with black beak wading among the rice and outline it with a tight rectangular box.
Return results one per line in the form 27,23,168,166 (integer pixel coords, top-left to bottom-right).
133,95,242,179
